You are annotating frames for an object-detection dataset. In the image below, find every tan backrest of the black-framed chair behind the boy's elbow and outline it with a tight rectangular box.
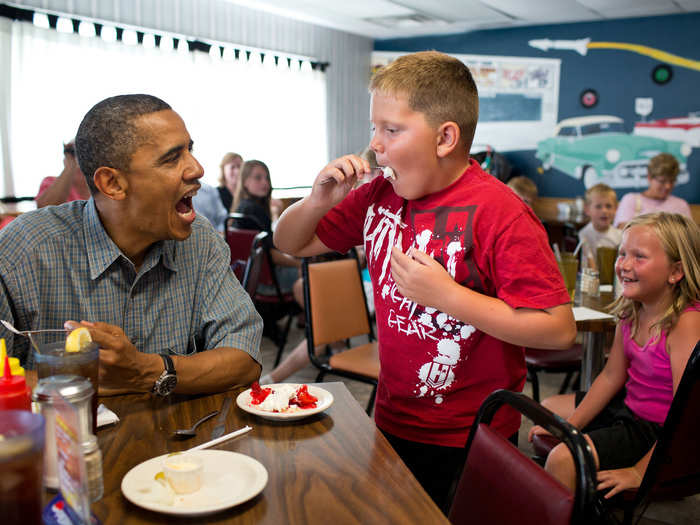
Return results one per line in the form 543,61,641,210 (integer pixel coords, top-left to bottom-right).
302,258,374,346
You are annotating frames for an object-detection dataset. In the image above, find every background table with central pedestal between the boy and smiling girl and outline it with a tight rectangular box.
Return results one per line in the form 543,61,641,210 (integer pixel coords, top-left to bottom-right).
576,292,615,390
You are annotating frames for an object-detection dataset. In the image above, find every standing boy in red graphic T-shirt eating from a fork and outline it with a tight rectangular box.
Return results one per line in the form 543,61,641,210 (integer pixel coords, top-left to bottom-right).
275,51,575,511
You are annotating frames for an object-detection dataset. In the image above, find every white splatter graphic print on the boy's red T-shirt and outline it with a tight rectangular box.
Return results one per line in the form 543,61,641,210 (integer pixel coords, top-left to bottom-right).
364,205,482,404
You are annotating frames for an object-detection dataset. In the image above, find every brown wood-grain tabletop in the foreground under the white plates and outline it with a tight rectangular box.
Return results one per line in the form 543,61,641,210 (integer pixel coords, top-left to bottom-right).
92,383,448,525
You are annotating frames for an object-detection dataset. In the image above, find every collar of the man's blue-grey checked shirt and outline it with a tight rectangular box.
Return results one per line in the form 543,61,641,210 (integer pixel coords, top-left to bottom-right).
83,197,178,280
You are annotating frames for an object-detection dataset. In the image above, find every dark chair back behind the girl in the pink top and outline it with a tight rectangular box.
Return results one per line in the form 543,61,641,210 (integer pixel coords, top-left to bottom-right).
635,341,700,506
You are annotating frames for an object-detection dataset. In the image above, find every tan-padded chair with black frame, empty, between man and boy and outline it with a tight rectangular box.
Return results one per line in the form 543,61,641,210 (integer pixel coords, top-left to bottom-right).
302,250,379,414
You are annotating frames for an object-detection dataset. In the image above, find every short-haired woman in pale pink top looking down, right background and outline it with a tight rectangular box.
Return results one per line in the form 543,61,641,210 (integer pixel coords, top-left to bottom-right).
614,153,692,229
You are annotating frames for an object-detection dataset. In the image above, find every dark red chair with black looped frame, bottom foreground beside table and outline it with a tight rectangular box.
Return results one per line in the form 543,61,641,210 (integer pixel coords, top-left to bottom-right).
449,390,595,525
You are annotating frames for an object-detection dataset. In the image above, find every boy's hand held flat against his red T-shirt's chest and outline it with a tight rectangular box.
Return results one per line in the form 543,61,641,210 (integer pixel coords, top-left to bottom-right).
391,246,456,310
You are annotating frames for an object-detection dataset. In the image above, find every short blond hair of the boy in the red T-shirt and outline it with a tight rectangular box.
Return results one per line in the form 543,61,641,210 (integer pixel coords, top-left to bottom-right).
369,51,479,151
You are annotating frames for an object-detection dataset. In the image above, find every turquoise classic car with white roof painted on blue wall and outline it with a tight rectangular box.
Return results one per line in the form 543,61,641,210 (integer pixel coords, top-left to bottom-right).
535,115,692,188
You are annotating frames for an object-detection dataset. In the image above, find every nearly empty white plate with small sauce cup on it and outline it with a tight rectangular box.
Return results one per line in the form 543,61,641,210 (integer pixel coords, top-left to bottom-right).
122,450,267,516
